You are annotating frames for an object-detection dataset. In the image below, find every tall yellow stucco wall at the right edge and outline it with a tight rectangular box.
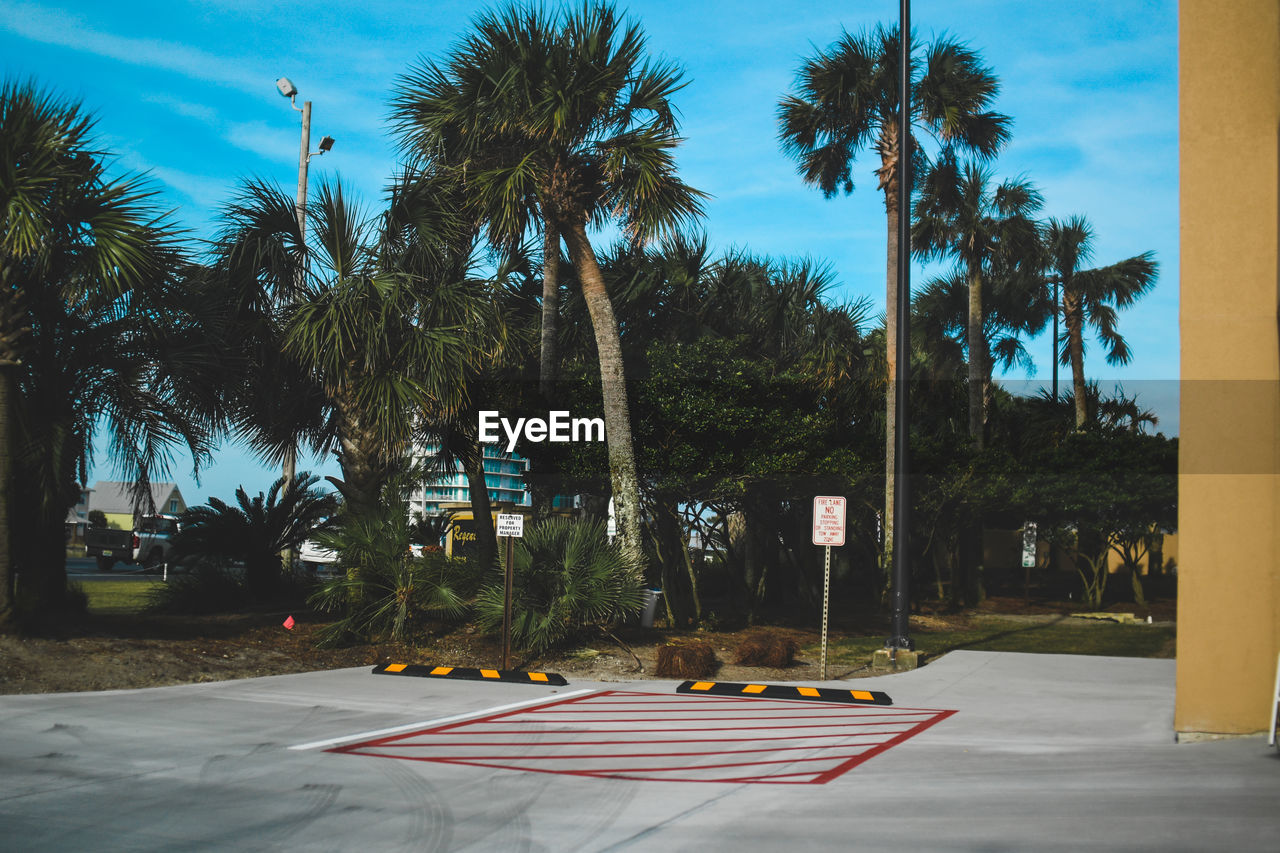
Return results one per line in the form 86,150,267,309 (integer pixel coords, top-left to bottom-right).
1174,0,1280,734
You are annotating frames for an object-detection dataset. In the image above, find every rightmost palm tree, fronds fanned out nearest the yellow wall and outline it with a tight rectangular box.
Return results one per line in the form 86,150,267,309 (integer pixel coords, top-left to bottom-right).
1044,216,1158,429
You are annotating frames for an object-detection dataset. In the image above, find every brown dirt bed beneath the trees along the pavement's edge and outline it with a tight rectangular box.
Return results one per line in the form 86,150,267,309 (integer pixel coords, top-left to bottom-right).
0,598,1174,694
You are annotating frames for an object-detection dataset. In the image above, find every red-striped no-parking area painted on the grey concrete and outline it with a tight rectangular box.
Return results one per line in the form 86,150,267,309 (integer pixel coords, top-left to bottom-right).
330,690,955,785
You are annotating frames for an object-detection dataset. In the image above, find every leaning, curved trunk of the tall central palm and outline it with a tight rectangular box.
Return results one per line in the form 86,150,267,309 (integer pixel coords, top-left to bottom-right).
563,218,645,566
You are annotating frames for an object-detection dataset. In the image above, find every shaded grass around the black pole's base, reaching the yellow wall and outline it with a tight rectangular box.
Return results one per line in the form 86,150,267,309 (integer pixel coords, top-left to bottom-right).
813,616,1176,667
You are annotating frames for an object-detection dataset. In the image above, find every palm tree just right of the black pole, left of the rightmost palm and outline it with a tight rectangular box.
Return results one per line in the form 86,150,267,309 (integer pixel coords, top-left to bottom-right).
911,154,1043,448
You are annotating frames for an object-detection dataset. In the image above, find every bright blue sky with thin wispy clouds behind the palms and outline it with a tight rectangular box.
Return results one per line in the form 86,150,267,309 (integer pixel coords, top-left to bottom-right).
0,0,1179,505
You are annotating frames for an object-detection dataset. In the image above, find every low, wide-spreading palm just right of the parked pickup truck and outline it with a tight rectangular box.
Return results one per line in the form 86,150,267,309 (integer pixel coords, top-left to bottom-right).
173,471,337,599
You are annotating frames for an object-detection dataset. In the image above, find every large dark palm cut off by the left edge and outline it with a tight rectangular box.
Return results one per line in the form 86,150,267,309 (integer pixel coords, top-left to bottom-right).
0,81,219,621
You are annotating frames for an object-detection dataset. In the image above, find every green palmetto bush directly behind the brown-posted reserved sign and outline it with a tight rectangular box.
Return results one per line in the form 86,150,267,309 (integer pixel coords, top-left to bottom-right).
476,519,645,653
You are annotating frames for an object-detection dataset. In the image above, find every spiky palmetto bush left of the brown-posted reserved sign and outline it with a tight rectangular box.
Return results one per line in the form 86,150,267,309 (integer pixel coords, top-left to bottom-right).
310,502,476,646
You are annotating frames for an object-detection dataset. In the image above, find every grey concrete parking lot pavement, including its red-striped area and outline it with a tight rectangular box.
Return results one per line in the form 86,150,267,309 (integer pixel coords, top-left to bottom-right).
0,652,1280,852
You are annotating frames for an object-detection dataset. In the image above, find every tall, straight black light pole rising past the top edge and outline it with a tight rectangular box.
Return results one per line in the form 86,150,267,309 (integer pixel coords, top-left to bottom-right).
884,0,915,653
